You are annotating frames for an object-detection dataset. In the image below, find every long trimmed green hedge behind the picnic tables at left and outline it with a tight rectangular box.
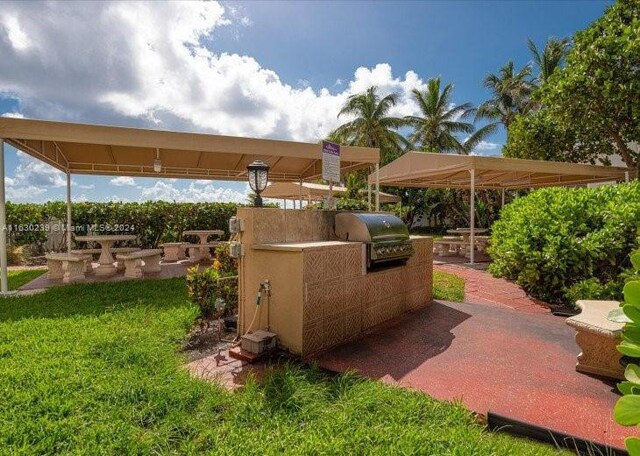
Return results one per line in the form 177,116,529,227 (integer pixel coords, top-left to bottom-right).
7,201,237,248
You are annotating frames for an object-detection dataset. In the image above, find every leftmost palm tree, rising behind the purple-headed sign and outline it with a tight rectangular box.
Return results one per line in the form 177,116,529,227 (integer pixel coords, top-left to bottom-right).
329,86,408,164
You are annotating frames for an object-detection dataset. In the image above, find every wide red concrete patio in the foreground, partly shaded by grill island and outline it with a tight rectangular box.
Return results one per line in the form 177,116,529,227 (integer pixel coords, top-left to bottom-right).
314,298,634,448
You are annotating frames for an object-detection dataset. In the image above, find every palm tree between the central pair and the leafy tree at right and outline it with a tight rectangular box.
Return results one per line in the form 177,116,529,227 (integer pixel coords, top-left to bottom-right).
476,61,534,129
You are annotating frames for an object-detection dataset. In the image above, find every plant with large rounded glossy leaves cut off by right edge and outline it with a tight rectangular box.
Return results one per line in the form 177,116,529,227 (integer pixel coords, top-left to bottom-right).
614,250,640,456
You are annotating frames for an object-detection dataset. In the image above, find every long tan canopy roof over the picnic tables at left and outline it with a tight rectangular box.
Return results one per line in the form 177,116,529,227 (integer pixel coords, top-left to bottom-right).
0,117,380,181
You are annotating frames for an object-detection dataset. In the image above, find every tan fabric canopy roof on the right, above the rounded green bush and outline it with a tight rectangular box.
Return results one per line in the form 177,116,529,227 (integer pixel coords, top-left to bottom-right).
369,152,629,189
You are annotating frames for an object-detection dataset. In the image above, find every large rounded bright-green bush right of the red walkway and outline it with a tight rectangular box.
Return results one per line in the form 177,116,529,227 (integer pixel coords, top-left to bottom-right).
489,181,640,304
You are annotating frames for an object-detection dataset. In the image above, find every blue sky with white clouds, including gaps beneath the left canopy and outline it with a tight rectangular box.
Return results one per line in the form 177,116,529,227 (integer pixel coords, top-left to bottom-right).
0,0,611,202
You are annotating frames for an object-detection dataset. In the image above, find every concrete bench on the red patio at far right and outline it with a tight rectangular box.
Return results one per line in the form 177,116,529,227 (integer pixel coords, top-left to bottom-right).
567,300,624,379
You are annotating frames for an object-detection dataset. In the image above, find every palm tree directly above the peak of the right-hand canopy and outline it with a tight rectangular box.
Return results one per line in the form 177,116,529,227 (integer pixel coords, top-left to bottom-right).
405,78,495,154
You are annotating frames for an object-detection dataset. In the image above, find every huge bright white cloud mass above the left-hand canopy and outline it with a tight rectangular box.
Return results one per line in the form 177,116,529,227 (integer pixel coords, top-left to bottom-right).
0,2,424,142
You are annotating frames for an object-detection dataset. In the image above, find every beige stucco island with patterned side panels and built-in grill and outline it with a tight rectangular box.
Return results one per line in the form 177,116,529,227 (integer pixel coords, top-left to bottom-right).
232,207,433,357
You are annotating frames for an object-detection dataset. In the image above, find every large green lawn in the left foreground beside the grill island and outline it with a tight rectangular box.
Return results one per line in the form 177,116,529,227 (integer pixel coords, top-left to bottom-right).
0,279,556,455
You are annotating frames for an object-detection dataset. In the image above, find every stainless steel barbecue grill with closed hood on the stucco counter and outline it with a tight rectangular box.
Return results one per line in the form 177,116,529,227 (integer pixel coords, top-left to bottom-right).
335,212,413,268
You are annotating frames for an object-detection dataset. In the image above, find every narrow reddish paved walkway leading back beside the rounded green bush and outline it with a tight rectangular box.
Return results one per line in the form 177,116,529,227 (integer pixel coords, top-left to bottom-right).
433,262,550,313
